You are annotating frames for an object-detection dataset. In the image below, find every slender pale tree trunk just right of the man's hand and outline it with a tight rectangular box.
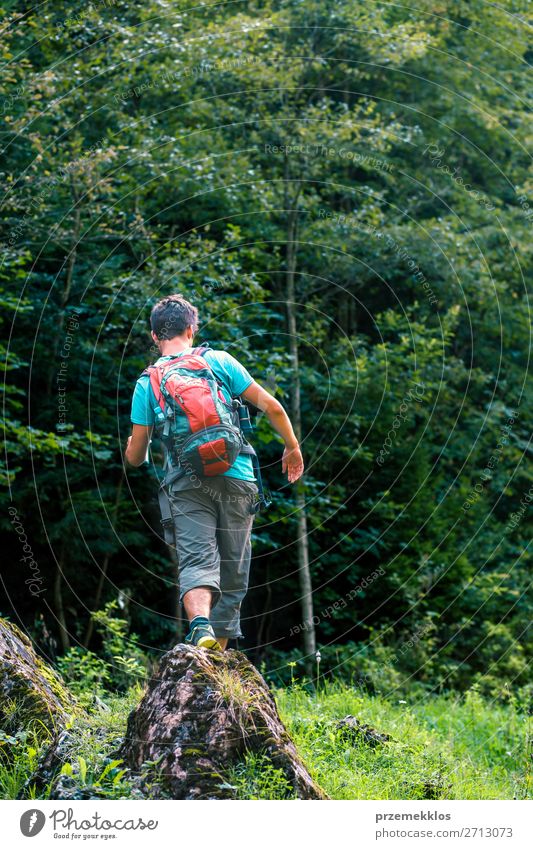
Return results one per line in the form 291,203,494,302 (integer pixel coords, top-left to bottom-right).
285,155,316,664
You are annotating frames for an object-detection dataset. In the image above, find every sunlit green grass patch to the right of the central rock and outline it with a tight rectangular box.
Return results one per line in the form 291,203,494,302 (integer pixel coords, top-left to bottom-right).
276,683,531,799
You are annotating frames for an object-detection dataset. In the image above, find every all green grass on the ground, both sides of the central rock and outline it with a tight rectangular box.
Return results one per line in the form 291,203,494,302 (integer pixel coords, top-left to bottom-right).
0,680,532,799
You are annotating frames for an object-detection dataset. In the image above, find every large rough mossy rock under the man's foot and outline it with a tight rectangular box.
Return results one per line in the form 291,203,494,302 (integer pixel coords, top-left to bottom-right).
118,644,327,799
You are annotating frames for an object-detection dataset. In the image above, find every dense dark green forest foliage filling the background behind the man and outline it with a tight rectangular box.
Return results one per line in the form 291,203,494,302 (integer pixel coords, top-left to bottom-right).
0,0,533,692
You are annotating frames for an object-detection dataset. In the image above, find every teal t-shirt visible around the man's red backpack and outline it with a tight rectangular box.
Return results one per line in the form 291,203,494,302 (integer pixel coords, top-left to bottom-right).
131,348,255,481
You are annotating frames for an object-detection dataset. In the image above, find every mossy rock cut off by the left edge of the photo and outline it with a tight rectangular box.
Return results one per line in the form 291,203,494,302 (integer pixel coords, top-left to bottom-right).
0,619,76,736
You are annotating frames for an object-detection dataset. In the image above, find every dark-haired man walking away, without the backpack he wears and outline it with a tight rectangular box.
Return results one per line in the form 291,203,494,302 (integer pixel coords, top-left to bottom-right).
125,295,304,651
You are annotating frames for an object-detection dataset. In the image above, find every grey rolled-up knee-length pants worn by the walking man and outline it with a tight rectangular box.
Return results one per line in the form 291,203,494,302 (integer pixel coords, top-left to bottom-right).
169,475,258,639
